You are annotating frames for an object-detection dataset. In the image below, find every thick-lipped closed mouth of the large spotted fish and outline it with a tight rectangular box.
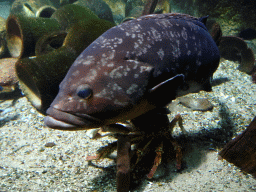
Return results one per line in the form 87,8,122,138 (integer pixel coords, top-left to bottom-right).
44,107,103,131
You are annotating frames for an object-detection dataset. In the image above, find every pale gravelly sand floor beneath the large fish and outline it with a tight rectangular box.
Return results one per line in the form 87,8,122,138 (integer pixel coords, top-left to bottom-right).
0,61,256,192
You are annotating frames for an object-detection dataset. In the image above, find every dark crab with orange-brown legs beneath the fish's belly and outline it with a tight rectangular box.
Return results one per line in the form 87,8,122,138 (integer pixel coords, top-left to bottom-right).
86,108,187,191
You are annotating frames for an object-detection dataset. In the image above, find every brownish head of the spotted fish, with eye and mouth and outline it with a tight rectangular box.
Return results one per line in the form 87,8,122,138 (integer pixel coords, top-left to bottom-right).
45,57,153,130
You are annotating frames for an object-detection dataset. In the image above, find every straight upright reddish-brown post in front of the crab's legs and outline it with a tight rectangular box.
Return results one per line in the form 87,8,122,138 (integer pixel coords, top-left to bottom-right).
116,135,131,192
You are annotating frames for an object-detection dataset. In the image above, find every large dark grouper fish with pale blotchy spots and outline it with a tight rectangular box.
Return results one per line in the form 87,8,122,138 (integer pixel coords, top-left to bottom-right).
44,13,220,131
